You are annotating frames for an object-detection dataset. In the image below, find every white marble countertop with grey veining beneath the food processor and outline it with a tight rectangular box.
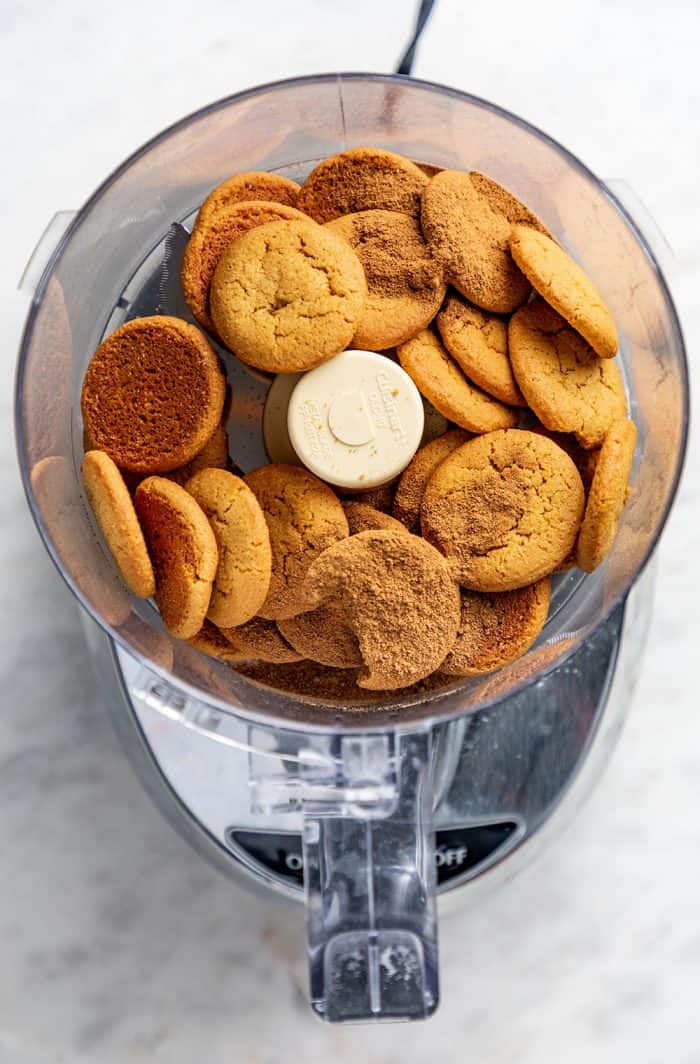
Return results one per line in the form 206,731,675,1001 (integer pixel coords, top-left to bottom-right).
0,0,700,1064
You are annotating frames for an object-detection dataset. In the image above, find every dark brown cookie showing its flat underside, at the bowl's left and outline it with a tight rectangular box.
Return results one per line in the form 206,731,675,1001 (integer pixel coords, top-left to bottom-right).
81,315,224,472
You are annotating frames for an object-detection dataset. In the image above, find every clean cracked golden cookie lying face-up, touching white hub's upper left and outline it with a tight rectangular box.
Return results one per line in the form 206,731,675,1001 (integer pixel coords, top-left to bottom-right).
210,220,367,373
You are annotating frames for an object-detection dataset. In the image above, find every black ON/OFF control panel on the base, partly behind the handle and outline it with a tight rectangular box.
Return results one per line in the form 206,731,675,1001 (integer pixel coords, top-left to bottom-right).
226,820,520,890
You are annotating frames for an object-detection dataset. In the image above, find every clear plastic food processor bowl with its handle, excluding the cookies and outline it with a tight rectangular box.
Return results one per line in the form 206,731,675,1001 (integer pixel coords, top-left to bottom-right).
17,74,687,1020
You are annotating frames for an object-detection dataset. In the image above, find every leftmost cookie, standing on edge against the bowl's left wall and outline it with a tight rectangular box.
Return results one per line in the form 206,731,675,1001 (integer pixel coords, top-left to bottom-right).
82,451,155,598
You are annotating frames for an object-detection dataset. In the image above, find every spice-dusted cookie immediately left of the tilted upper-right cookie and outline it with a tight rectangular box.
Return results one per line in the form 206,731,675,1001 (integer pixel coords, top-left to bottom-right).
420,170,544,314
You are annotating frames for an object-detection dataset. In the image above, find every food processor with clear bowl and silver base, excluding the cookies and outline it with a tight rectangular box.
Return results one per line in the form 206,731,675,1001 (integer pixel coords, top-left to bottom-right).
17,74,688,1021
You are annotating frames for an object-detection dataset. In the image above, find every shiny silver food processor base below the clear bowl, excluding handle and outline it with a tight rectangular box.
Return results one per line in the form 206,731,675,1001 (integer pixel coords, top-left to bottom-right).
81,564,654,901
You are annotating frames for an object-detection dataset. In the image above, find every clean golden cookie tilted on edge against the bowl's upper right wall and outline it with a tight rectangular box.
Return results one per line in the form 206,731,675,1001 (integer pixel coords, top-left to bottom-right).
510,226,618,359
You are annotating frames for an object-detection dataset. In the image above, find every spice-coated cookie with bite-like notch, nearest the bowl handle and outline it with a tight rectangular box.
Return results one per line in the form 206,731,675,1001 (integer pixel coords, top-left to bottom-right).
297,530,460,691
